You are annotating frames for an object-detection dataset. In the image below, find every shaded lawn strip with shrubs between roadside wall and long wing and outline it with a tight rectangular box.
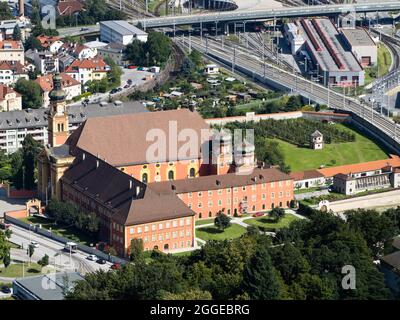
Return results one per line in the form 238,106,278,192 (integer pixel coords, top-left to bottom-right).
21,217,96,246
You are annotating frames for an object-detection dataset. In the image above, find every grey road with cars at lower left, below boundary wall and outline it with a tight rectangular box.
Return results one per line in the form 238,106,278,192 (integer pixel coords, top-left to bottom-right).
10,225,111,274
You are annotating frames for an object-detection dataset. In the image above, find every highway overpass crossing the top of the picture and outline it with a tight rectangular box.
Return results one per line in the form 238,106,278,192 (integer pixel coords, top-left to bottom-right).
130,1,400,28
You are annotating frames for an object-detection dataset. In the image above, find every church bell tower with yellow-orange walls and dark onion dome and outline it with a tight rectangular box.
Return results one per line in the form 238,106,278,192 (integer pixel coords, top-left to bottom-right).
48,73,69,147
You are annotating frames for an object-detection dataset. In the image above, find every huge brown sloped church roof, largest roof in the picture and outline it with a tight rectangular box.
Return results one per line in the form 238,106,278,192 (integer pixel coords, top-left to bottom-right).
68,109,209,166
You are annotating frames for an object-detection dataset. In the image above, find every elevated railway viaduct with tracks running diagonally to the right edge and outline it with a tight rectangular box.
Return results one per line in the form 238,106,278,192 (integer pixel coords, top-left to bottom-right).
180,37,400,149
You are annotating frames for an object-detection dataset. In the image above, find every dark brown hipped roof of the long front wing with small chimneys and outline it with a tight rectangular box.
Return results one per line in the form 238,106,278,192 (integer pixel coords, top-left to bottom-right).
61,153,195,226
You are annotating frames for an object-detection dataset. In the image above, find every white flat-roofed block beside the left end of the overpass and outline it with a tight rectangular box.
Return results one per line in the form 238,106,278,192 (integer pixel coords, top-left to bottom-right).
100,20,148,45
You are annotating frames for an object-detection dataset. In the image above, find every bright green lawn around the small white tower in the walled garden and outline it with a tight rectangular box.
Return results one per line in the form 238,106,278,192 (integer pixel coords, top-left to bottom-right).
277,124,388,172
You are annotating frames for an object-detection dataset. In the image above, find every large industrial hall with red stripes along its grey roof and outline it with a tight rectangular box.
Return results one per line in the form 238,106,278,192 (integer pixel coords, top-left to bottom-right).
285,19,364,87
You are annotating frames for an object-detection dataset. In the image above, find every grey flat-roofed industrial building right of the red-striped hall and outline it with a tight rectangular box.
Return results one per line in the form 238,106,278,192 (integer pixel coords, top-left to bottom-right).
341,29,378,67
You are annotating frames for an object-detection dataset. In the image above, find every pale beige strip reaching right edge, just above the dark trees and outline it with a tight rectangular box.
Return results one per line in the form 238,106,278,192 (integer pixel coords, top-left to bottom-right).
329,190,400,213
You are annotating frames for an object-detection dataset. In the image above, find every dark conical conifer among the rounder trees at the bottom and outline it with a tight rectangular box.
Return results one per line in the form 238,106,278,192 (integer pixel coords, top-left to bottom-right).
242,246,281,300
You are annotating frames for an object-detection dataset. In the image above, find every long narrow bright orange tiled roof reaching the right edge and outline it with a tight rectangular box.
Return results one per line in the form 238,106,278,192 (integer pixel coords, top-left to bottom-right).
318,155,400,178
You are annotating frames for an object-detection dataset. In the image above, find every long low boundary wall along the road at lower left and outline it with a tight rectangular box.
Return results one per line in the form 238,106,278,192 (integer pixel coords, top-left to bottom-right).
4,214,127,264
